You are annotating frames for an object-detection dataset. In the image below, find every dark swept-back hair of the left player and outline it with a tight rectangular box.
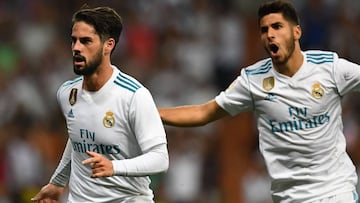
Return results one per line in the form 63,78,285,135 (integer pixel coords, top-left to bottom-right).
72,5,123,46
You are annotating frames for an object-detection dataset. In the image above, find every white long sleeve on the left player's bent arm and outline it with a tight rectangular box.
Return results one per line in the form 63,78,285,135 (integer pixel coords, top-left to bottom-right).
113,88,169,176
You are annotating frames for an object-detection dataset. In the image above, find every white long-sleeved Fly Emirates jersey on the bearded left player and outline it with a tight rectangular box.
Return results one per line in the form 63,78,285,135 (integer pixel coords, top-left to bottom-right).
50,67,168,203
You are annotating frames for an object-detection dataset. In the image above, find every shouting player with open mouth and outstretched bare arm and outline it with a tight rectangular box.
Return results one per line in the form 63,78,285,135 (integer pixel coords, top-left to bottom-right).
159,0,360,203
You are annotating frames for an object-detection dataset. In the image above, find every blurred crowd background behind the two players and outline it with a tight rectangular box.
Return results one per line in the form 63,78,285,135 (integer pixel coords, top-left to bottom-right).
0,0,360,203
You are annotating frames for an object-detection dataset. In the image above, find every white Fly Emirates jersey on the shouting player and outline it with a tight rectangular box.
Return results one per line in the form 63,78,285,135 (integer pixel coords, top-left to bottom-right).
215,51,360,203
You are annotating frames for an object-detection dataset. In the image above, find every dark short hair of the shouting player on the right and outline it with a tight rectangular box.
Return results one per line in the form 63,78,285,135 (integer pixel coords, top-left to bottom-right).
258,0,300,25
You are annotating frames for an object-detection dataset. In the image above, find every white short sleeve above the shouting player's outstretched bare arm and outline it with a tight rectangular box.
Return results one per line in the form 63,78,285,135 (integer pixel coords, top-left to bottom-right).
215,69,253,116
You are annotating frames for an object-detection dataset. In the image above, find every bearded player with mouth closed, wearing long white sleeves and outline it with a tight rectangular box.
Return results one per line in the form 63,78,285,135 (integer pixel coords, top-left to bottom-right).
31,7,169,203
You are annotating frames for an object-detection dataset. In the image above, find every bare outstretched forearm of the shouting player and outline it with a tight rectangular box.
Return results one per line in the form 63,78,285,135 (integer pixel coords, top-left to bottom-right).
158,100,228,127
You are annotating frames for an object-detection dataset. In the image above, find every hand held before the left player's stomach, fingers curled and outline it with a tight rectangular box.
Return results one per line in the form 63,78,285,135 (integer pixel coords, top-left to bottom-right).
82,151,114,178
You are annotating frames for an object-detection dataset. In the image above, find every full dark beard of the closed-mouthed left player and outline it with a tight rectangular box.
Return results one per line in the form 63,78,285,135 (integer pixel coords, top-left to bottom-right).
73,50,102,76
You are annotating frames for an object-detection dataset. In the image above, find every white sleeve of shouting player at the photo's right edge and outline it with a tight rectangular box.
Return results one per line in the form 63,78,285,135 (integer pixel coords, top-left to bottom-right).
334,58,360,96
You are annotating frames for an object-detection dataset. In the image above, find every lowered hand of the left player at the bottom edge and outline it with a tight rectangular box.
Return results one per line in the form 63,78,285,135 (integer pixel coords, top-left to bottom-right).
31,183,64,203
